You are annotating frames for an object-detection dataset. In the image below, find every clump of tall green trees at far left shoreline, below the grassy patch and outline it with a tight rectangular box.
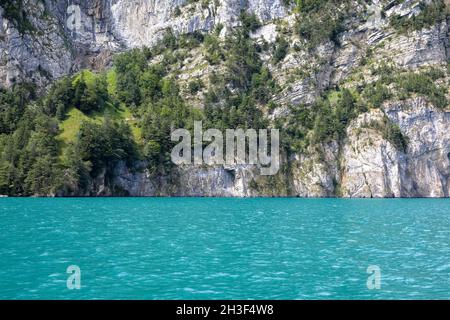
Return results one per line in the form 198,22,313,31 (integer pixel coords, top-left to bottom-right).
0,109,61,196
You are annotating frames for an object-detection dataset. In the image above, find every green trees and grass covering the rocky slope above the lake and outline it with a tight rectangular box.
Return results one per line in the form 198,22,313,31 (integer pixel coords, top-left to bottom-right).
0,0,448,195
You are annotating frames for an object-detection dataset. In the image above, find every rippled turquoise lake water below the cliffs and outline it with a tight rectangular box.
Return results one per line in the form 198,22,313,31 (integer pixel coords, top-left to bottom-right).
0,198,450,299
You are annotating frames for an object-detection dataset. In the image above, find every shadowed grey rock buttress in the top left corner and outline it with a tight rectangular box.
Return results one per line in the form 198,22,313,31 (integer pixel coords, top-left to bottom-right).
0,1,73,87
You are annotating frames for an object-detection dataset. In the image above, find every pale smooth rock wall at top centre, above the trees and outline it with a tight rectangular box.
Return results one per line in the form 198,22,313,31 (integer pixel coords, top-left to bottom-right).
110,0,286,47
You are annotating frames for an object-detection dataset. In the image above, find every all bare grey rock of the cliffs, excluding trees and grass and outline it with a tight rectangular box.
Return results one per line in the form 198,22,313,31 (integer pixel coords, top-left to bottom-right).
0,0,450,197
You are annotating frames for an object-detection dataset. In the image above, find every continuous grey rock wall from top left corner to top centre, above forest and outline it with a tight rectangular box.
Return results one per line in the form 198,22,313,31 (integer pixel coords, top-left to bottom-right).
0,0,286,86
